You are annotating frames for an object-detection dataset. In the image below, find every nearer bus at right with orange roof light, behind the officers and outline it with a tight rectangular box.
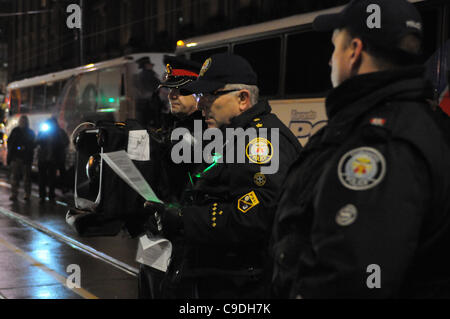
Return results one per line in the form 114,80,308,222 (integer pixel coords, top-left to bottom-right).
175,0,450,145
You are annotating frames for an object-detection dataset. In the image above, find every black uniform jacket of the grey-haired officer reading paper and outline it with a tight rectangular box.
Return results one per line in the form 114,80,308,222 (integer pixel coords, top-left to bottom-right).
178,102,301,276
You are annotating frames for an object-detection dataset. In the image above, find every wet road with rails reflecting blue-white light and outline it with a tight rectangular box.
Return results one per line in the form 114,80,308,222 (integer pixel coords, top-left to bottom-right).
0,171,139,299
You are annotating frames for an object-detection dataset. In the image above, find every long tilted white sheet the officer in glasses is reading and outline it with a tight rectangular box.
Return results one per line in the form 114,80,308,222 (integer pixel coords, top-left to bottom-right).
101,151,163,203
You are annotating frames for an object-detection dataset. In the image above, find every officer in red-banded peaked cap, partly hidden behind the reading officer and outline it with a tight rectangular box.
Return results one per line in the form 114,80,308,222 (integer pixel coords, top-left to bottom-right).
134,56,205,299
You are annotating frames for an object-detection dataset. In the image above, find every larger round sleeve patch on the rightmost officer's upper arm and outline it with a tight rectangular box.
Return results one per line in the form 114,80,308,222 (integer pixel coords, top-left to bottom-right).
338,147,386,191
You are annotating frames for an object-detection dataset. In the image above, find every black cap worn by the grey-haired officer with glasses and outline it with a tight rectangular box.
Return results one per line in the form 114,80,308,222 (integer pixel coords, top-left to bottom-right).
183,53,258,93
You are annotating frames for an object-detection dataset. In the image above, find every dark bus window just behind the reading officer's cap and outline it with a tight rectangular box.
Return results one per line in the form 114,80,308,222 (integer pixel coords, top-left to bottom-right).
233,37,281,96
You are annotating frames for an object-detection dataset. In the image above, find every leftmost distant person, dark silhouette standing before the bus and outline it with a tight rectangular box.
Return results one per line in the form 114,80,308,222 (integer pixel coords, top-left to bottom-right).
7,115,35,201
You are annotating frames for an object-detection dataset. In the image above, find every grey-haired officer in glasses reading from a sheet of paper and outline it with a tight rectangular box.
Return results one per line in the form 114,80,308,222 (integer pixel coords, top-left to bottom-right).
146,54,301,298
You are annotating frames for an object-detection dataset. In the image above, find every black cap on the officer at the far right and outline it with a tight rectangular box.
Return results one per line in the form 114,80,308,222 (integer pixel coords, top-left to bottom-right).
313,0,423,48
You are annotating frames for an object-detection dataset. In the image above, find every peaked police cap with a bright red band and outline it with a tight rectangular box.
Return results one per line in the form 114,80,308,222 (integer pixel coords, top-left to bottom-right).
159,55,201,88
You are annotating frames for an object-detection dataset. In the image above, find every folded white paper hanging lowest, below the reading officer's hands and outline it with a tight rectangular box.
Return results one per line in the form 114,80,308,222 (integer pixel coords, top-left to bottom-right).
136,235,172,272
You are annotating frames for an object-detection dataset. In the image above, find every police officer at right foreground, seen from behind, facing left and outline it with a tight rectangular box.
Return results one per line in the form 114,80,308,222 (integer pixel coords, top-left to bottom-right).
273,0,450,298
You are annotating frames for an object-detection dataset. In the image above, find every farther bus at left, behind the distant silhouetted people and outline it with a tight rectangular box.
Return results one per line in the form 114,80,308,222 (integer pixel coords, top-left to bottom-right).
5,53,171,170
